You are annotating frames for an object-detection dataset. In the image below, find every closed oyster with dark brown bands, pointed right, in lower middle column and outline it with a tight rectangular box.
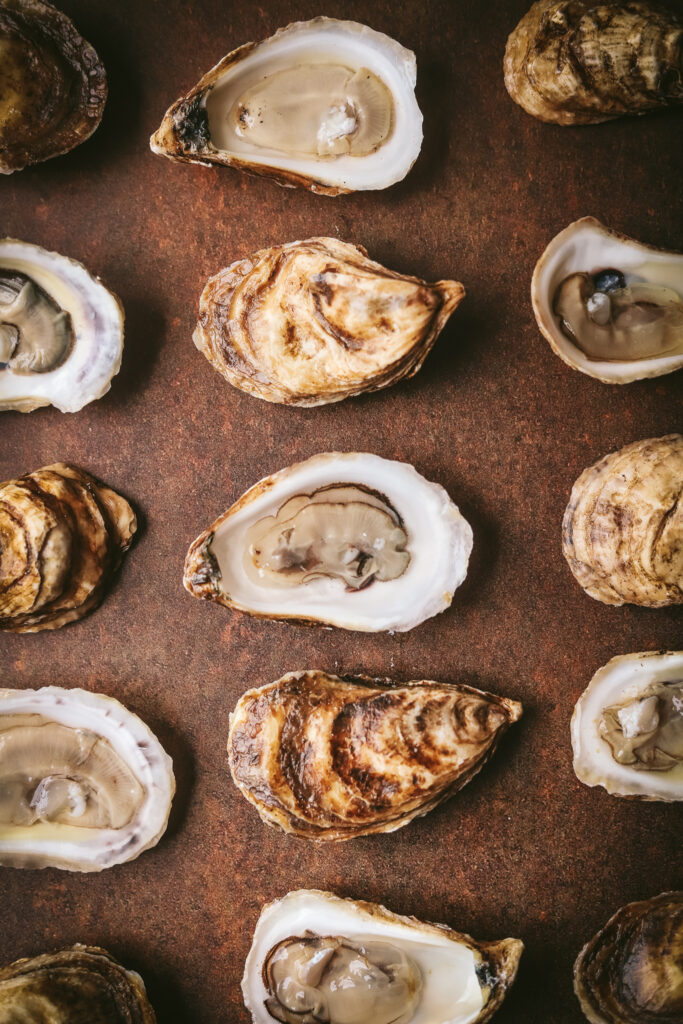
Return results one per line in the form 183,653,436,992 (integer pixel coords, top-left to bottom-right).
227,671,522,840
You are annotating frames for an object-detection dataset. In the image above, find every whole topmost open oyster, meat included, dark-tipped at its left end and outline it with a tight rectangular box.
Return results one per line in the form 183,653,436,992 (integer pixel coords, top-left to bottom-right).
151,17,422,196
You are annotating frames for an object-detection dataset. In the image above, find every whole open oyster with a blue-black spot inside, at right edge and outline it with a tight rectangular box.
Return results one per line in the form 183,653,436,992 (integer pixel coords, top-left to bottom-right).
531,217,683,384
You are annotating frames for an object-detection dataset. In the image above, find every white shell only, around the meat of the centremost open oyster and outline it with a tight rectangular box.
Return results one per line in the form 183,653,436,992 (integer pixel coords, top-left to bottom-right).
183,452,472,632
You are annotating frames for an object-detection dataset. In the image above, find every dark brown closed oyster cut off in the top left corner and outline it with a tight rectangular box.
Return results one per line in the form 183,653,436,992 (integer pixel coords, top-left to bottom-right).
0,0,106,174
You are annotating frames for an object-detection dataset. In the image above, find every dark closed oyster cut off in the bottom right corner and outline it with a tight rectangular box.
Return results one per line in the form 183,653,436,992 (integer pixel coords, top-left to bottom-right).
573,892,683,1024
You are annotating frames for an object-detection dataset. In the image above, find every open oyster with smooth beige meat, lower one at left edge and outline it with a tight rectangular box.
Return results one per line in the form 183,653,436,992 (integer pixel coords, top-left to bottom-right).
0,686,175,868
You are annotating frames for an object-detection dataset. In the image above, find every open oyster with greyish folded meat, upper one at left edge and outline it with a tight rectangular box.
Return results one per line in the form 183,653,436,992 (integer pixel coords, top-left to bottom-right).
0,239,123,413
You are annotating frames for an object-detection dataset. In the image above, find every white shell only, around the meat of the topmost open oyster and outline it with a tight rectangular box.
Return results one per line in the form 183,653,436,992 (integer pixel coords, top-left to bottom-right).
150,17,422,196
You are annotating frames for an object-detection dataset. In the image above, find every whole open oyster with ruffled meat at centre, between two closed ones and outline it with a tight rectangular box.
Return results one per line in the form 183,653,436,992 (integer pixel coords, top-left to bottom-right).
183,452,472,632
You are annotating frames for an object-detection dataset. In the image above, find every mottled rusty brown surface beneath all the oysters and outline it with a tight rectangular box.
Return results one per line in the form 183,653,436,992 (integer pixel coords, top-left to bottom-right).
0,0,683,1024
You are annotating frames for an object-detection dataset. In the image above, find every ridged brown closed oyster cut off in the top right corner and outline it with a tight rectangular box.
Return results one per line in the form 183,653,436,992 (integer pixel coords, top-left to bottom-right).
504,0,683,125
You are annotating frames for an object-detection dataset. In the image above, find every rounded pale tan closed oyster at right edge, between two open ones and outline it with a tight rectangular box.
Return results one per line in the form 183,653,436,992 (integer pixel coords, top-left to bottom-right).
562,434,683,608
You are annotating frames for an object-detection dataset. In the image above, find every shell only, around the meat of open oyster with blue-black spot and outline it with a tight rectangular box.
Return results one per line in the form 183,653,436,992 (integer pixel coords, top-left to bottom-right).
531,217,683,384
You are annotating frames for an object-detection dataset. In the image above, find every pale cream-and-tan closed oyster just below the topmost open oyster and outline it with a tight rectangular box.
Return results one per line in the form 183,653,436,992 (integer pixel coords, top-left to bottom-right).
194,238,465,406
